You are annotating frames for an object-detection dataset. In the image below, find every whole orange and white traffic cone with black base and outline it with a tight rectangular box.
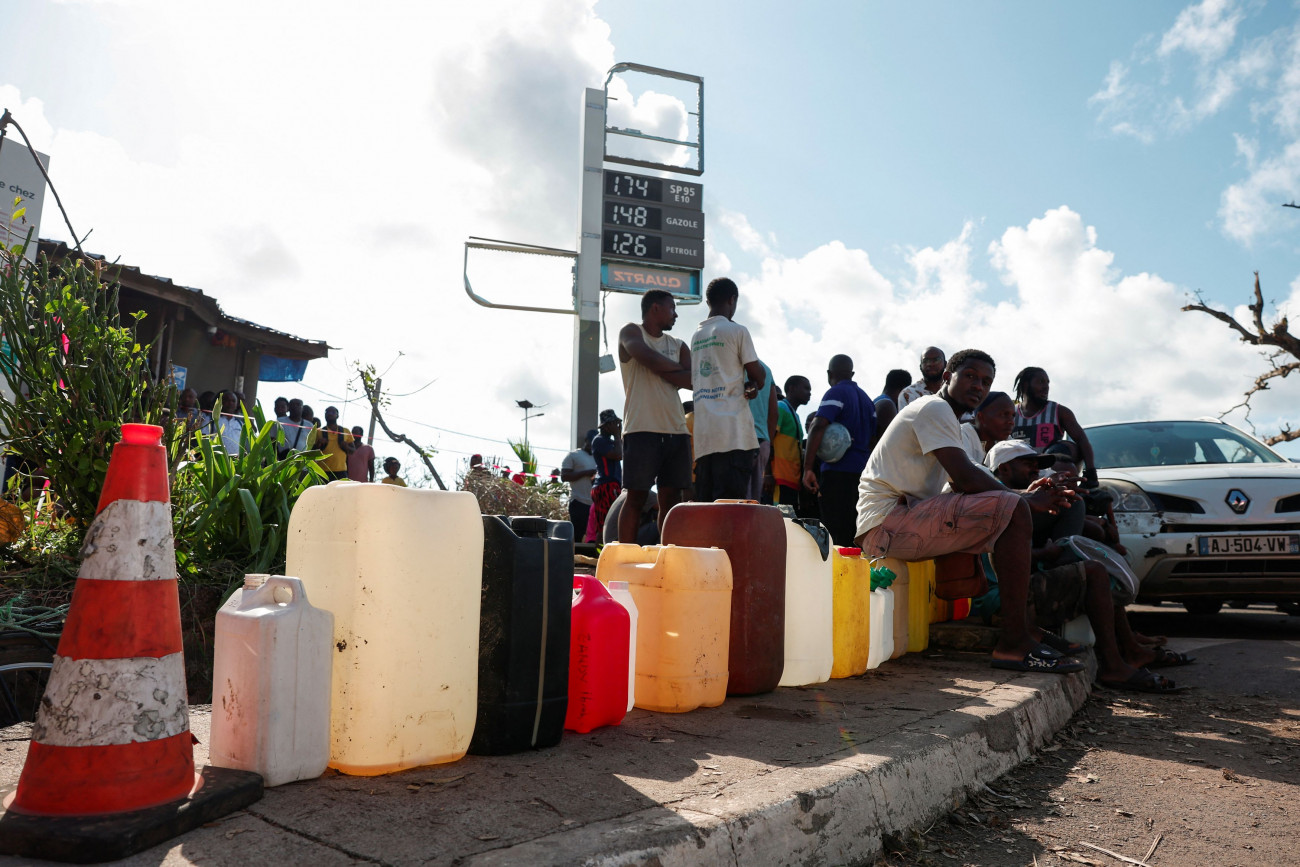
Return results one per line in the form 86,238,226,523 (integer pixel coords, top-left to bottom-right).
0,425,261,861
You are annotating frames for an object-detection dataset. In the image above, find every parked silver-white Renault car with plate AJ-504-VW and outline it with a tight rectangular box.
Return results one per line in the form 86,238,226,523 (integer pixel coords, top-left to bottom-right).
1087,420,1300,614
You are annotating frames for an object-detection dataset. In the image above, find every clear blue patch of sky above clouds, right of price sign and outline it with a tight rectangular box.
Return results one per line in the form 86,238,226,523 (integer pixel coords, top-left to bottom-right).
597,0,1300,303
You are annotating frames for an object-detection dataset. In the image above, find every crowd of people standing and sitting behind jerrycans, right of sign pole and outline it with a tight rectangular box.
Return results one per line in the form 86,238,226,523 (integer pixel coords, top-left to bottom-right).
560,278,1192,693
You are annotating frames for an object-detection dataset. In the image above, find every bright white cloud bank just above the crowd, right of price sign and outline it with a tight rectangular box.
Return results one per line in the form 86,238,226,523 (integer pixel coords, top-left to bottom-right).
728,207,1284,428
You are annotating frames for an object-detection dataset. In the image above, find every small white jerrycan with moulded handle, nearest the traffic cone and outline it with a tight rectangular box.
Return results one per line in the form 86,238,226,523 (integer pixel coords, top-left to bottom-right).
211,575,334,786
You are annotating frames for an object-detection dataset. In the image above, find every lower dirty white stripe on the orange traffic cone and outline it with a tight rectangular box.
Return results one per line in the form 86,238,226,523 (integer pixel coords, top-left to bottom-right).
31,654,190,746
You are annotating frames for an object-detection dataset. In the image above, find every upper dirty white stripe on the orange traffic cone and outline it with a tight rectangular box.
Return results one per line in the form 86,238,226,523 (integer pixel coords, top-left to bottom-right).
77,499,176,581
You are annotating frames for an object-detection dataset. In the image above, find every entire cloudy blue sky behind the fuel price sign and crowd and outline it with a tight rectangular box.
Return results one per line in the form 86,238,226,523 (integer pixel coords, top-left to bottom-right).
0,0,1300,477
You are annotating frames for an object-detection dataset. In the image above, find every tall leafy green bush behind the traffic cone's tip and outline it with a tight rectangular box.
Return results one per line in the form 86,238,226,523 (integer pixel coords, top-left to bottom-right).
0,238,176,528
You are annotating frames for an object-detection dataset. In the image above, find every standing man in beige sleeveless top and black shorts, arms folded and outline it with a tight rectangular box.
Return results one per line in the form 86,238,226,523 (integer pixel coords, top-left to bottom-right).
616,289,690,542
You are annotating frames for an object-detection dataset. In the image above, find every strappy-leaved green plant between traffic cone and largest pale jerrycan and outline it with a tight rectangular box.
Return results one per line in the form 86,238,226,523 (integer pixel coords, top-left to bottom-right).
172,407,325,578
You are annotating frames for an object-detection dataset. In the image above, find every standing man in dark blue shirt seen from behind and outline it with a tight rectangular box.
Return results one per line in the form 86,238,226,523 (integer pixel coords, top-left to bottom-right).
803,355,876,547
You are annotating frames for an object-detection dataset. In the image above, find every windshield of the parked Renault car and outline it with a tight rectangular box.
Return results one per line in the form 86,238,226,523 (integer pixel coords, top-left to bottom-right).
1088,421,1286,469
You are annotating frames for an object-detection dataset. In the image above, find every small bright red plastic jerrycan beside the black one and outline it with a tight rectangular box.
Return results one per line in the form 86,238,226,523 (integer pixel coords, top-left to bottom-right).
564,575,632,733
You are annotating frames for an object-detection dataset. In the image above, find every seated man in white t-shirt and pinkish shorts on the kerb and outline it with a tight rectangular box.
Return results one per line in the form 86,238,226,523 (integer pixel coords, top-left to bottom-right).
857,350,1083,673
